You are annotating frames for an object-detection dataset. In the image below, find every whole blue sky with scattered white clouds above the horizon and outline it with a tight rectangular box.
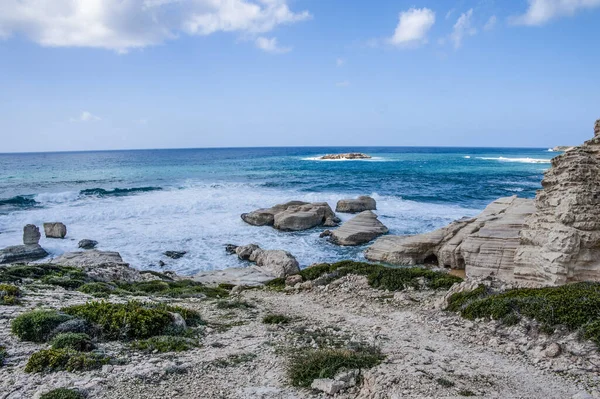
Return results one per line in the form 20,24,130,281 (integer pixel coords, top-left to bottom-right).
0,0,600,152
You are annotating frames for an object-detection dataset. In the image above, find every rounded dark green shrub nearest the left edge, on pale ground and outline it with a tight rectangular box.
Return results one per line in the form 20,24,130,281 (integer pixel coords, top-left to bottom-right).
11,310,71,342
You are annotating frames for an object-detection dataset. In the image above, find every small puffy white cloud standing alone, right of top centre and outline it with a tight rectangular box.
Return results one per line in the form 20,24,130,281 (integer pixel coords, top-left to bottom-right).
390,8,435,46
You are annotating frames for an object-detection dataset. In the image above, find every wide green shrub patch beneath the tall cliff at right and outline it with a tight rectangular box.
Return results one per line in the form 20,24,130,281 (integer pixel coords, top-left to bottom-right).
461,283,600,346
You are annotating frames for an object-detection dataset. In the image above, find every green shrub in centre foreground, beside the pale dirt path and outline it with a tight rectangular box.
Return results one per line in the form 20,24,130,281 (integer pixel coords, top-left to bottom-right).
288,348,383,387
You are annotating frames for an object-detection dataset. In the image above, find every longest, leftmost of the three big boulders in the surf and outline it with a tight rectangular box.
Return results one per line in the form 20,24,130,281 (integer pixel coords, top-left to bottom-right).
241,201,340,231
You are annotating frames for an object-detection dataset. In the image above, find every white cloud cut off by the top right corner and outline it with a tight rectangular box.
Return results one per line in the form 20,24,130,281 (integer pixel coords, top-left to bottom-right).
510,0,600,26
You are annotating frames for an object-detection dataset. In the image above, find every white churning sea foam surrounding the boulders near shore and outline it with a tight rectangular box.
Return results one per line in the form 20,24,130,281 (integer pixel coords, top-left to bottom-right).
0,182,478,274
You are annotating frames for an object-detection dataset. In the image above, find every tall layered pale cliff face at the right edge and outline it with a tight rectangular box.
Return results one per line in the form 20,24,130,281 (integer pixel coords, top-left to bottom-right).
515,120,600,285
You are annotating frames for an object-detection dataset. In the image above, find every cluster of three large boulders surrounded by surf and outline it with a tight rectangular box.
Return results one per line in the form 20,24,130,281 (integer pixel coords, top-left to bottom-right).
241,196,388,246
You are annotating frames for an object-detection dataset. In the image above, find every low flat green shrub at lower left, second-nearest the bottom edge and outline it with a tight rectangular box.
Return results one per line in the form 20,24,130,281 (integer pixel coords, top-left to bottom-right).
25,349,109,373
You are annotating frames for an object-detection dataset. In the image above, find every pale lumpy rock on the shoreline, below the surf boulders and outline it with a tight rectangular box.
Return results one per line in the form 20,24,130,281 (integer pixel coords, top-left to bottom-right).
227,244,300,278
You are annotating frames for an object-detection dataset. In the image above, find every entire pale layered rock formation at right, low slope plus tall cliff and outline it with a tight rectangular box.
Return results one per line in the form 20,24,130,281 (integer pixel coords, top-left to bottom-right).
365,120,600,285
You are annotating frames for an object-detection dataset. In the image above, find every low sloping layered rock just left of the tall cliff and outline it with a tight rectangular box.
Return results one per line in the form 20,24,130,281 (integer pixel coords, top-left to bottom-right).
365,197,535,278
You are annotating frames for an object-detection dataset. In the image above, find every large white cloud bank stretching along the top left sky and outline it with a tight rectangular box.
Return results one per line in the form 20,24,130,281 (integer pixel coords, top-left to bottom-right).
0,0,311,52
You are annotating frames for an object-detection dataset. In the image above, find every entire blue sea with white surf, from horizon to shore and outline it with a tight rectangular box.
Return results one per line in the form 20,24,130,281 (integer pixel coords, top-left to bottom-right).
0,147,557,275
